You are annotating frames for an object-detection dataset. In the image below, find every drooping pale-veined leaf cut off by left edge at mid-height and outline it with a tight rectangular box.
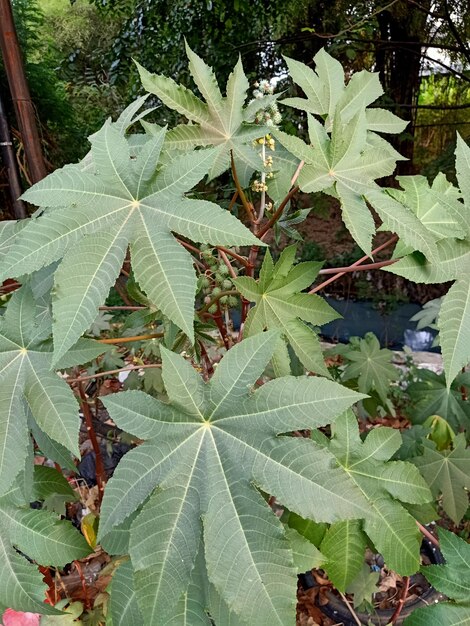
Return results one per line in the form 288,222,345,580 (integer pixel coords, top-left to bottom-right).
0,287,93,494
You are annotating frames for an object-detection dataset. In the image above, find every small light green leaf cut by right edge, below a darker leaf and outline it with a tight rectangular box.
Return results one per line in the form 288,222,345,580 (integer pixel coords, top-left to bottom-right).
413,433,470,524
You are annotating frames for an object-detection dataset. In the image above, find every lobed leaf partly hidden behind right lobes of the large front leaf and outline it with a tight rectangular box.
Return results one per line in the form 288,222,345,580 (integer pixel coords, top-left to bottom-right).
325,411,432,575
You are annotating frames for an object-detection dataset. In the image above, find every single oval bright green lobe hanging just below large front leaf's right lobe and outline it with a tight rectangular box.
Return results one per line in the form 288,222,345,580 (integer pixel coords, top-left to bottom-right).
320,520,367,593
